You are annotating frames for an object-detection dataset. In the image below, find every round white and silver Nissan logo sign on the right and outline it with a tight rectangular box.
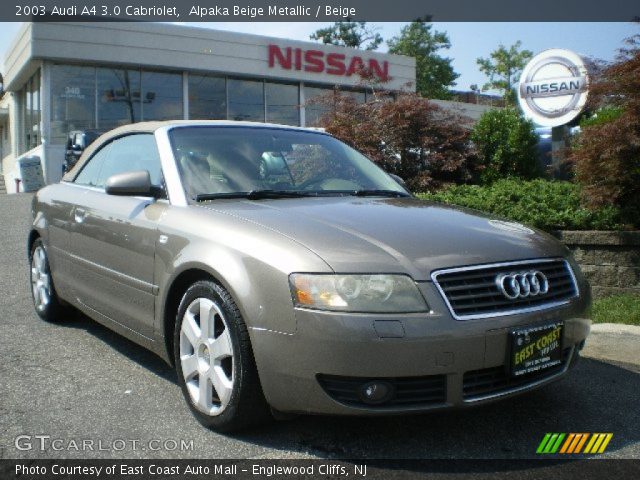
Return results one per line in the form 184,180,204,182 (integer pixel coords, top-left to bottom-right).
518,48,589,127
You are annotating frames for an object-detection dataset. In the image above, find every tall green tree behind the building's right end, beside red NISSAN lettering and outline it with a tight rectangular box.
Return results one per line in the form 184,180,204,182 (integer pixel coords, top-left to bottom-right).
387,21,460,99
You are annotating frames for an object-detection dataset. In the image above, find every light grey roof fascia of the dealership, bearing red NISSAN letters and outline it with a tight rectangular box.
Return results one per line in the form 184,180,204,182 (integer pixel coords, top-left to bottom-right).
5,22,415,89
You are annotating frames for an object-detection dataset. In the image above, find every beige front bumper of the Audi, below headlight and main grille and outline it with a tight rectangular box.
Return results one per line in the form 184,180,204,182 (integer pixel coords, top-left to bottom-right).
251,285,590,415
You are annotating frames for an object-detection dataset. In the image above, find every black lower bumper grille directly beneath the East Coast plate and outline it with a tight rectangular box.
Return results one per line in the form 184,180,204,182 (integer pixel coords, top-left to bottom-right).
462,348,572,400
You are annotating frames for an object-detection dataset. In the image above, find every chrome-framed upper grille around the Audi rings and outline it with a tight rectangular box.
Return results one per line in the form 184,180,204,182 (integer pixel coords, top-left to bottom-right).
432,259,578,320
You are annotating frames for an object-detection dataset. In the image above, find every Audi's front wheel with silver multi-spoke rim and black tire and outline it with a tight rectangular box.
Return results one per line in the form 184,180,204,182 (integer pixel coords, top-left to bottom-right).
173,280,271,432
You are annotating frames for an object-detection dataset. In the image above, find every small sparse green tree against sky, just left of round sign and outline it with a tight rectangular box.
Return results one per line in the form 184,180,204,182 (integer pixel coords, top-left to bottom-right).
476,40,533,105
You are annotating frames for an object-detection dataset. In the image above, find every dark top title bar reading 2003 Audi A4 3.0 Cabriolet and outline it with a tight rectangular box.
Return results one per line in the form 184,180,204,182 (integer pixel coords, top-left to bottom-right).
5,0,640,23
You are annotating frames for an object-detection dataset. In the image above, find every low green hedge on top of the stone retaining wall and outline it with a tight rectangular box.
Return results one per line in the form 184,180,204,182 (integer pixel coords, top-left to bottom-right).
418,179,622,231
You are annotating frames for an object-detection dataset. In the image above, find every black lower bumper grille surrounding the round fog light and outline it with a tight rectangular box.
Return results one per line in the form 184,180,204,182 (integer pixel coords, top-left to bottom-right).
318,375,447,408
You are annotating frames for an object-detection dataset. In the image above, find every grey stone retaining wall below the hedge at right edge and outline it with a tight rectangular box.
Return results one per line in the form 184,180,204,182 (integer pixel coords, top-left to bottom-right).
557,231,640,297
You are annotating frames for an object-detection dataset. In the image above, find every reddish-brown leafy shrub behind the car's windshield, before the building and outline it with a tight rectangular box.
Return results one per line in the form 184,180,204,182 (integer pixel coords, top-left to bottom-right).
315,91,478,191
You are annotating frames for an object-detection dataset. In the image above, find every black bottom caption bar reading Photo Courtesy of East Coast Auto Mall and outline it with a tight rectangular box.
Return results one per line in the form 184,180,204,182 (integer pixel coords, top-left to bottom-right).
0,459,640,480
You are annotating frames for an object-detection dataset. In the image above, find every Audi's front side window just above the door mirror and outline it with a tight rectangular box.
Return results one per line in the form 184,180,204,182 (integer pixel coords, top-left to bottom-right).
97,133,163,187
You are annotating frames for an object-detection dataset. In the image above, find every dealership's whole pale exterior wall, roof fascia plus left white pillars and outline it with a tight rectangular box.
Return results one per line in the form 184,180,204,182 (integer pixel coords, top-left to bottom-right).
2,22,415,193
